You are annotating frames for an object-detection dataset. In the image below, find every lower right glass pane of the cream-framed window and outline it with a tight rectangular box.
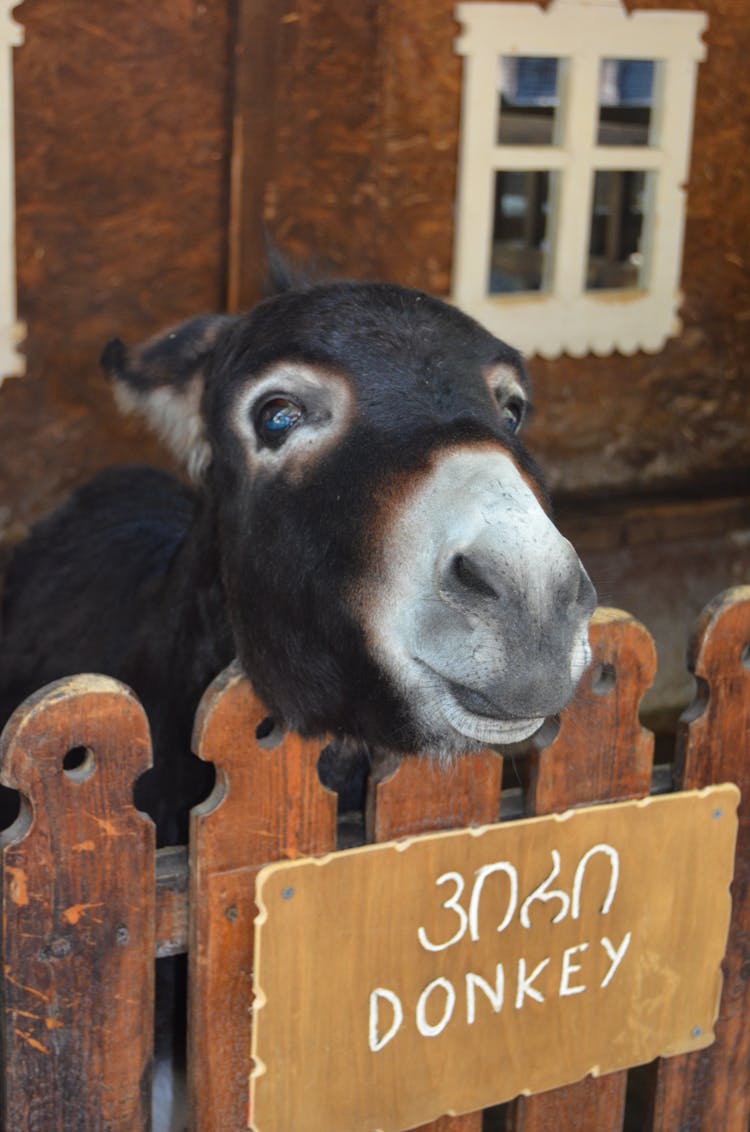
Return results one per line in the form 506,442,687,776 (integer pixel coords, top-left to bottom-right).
586,170,654,291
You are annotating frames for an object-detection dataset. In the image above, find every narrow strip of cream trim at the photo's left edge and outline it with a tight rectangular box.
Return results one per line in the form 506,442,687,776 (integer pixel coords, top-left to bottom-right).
0,0,26,385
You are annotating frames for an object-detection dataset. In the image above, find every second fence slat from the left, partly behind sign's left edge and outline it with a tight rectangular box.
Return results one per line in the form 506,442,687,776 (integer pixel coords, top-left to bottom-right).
188,664,336,1132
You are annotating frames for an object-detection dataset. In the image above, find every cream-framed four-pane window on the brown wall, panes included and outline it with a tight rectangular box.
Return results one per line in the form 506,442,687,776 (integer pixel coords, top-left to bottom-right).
454,0,706,358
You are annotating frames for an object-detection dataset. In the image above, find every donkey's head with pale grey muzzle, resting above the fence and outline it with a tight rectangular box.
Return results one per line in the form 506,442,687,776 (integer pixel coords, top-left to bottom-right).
103,283,595,755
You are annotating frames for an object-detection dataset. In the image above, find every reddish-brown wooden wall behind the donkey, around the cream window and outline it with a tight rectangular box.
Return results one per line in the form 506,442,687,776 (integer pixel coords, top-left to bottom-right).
0,0,750,715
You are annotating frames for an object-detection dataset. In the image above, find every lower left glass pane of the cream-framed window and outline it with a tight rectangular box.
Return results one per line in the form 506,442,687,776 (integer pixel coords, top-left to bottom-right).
489,170,558,294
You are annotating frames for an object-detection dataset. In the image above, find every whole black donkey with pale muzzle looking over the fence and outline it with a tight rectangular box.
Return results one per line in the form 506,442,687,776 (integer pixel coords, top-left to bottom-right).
0,276,595,843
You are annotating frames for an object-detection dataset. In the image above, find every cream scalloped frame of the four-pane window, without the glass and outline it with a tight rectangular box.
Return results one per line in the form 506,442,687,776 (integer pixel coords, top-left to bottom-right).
452,0,707,358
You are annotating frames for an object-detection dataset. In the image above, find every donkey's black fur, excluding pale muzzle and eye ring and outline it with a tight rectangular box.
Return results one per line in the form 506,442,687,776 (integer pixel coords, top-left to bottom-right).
0,284,543,843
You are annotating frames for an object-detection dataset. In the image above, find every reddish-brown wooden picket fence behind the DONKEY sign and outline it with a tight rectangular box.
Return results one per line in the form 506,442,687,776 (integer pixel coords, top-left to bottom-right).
0,588,750,1132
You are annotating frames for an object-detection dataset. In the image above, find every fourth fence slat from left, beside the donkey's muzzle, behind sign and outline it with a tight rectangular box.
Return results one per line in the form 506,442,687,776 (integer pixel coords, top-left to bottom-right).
507,609,656,1132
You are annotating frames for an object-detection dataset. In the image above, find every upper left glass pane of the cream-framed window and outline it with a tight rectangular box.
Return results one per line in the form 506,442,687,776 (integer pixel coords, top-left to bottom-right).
498,55,560,145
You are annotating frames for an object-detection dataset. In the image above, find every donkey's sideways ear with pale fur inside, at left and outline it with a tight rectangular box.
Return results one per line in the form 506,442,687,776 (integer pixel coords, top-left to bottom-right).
101,315,236,479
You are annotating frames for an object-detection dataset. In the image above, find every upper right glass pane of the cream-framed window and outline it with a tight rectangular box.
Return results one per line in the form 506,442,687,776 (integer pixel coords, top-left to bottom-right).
596,59,655,145
